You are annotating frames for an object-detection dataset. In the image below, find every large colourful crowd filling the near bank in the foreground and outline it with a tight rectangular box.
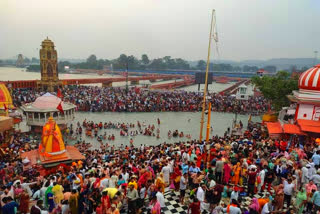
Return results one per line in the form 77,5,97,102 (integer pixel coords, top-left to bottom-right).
0,123,320,214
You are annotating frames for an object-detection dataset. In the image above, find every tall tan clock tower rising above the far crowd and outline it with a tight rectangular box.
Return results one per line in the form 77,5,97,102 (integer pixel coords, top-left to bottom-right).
38,37,61,92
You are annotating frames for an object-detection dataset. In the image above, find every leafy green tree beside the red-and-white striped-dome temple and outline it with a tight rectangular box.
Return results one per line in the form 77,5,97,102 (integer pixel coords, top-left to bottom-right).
251,71,298,111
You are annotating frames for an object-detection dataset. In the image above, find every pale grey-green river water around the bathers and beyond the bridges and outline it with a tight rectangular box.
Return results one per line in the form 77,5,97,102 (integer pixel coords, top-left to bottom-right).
0,67,260,148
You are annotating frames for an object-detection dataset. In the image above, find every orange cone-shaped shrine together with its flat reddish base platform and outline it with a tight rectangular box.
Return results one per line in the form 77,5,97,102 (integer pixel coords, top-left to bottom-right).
21,117,85,168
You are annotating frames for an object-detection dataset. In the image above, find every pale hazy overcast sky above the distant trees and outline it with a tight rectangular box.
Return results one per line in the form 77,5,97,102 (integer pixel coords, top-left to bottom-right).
0,0,320,60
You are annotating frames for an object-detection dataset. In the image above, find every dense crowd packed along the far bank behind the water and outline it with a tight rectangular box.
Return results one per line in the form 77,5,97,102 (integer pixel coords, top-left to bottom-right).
12,86,269,114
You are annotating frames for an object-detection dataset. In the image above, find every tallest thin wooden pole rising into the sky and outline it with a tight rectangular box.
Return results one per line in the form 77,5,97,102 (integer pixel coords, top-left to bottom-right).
199,10,215,141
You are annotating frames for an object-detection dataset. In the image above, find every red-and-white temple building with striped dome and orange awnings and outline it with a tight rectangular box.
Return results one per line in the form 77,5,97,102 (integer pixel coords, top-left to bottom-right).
267,64,320,138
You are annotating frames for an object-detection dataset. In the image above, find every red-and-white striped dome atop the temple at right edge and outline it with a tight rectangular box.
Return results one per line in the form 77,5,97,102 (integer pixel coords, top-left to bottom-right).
299,64,320,91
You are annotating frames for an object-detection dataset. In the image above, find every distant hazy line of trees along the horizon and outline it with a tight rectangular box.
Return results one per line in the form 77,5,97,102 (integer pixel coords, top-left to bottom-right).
21,54,277,72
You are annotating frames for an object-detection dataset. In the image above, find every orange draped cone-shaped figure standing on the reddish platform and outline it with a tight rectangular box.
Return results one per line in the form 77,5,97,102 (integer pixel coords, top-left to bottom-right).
39,117,66,157
